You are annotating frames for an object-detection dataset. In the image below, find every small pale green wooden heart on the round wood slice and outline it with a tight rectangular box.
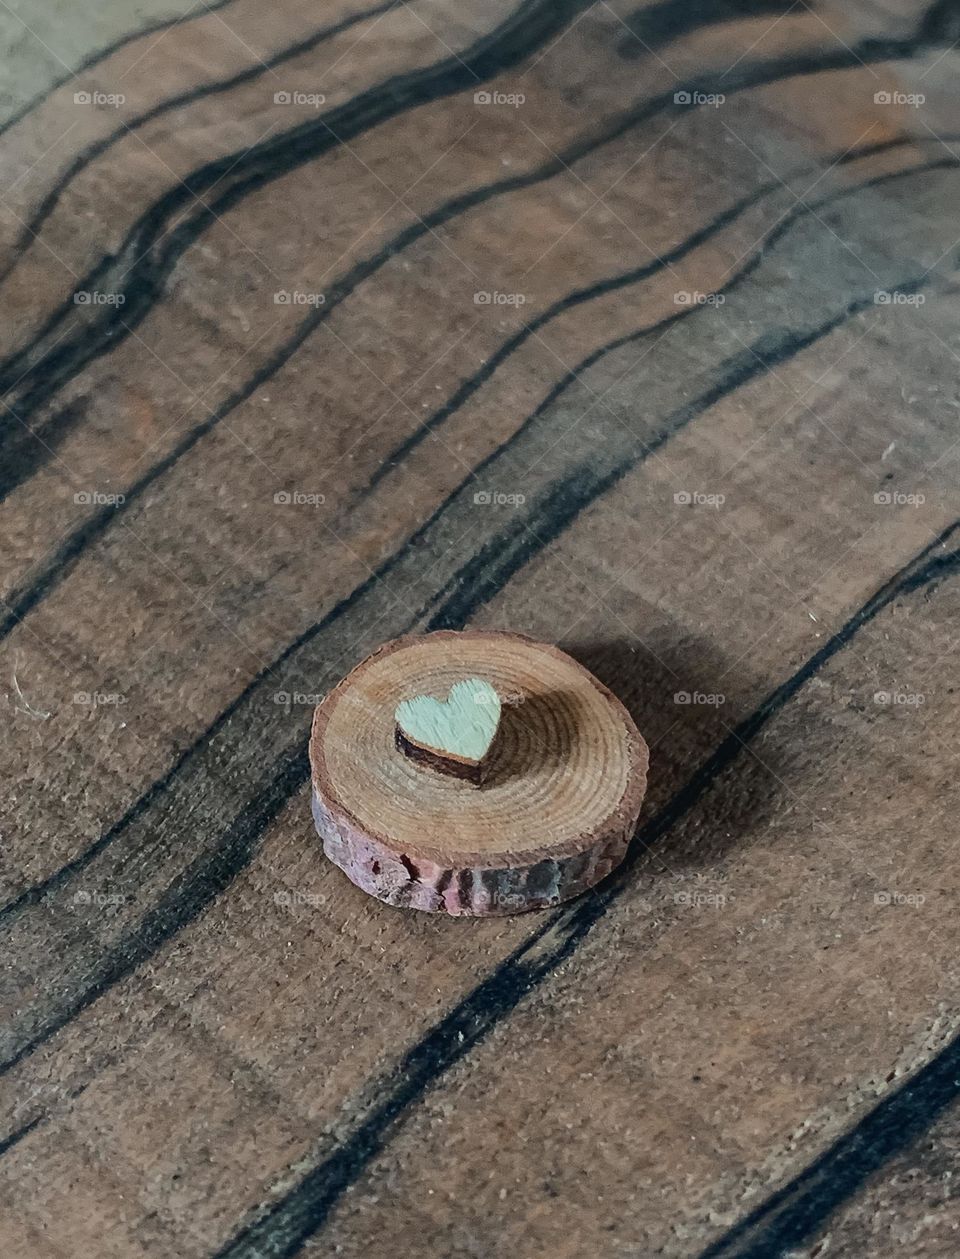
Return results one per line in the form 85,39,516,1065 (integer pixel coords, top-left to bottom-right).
395,677,501,764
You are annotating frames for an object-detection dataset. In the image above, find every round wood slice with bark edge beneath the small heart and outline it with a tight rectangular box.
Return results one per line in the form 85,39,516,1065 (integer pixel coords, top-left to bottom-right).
310,630,648,914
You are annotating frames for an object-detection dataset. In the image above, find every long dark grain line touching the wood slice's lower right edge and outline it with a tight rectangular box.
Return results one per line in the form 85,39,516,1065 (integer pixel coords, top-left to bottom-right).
214,521,960,1259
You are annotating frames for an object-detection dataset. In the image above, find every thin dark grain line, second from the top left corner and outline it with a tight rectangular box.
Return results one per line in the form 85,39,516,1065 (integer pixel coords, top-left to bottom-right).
0,0,404,285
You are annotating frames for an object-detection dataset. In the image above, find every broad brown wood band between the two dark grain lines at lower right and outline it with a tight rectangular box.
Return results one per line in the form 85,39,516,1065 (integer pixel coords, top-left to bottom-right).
312,554,957,1255
